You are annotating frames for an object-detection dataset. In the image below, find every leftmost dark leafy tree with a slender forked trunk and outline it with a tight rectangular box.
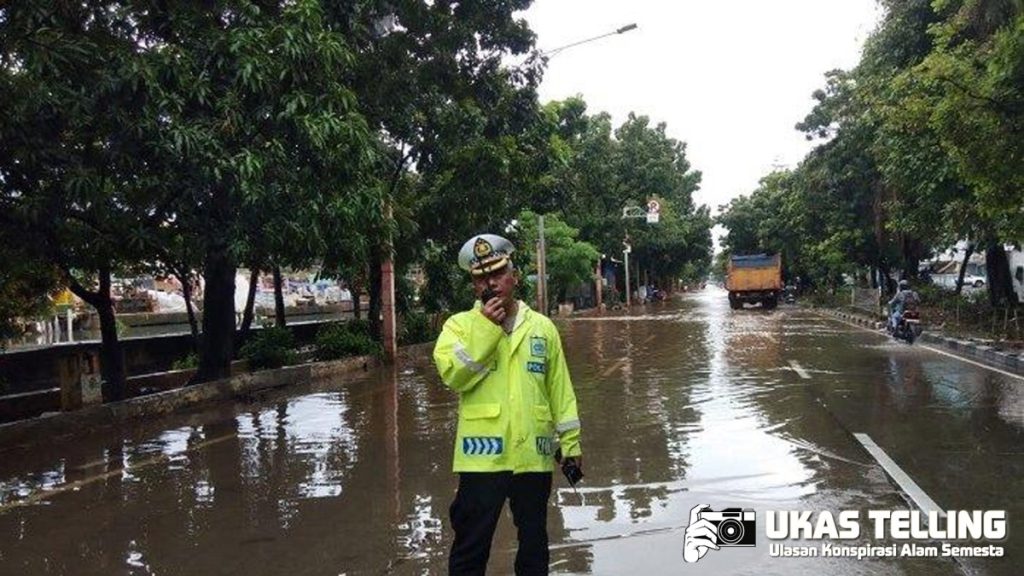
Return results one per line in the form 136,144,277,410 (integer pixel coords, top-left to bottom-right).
0,2,176,393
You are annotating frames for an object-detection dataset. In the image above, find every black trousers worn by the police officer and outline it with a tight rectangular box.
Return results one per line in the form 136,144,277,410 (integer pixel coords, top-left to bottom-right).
449,471,551,576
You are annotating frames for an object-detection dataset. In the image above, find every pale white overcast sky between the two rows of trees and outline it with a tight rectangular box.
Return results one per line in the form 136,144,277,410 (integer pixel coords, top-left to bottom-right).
523,0,880,218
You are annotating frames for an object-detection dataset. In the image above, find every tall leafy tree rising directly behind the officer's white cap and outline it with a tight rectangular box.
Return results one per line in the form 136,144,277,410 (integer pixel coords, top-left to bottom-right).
328,0,540,330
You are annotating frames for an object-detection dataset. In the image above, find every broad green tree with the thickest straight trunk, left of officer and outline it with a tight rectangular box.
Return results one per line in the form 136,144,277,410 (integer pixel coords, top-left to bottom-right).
132,0,373,380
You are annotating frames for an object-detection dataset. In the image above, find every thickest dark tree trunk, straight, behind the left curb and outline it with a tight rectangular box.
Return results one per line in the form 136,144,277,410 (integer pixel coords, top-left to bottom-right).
195,240,234,382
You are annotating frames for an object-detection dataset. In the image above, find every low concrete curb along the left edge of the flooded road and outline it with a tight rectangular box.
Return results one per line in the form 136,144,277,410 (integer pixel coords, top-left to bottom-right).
0,342,433,451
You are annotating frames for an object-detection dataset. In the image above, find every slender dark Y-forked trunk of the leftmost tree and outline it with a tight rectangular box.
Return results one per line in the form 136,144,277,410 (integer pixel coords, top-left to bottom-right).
65,265,128,402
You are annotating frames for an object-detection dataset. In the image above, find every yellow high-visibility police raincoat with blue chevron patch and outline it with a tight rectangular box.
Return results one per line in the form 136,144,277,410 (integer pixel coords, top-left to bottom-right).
434,300,582,472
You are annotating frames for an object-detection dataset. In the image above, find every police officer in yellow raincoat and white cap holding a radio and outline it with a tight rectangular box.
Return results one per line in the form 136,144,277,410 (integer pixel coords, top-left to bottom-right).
434,234,582,575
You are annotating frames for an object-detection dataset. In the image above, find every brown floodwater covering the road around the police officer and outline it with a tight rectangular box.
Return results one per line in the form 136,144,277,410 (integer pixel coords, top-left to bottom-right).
0,289,1024,576
